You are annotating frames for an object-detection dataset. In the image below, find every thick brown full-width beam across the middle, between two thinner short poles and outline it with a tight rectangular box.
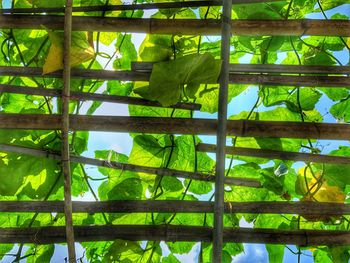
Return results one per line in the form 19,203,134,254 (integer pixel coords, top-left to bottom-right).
0,114,350,140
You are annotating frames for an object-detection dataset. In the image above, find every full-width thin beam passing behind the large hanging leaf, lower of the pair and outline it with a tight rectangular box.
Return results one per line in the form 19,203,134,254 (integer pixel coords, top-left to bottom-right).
0,66,350,88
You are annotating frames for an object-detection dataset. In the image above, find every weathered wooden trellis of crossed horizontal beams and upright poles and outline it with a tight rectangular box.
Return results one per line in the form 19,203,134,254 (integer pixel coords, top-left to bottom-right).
0,0,350,262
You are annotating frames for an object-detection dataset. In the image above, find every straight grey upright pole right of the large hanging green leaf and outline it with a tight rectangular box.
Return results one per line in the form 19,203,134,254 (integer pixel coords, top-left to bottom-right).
213,0,232,262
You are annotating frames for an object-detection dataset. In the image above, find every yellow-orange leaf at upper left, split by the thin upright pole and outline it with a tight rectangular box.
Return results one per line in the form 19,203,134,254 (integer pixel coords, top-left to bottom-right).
43,31,95,74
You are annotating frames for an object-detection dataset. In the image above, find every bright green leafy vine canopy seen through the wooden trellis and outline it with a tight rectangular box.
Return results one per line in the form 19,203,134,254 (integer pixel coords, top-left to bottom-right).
0,0,350,263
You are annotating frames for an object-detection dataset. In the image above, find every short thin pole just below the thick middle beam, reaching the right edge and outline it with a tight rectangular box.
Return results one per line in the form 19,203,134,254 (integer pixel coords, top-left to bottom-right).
197,143,350,164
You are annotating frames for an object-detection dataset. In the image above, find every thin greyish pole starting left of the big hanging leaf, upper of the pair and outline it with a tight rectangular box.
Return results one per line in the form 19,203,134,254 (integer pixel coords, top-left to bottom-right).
131,62,350,75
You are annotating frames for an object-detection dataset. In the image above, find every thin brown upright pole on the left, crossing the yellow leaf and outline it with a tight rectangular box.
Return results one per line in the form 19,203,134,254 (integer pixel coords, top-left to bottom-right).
62,0,76,263
